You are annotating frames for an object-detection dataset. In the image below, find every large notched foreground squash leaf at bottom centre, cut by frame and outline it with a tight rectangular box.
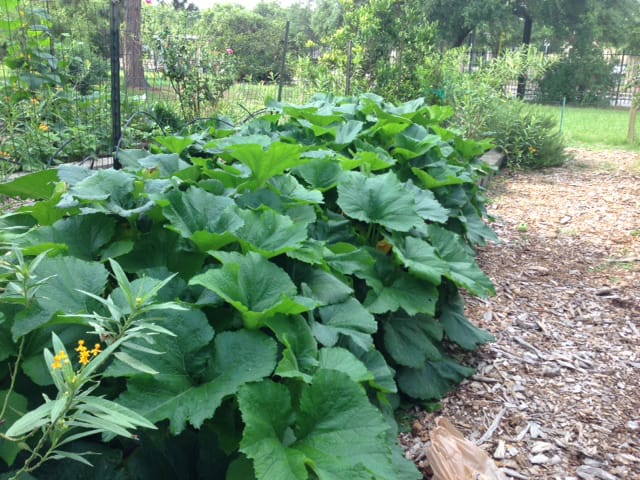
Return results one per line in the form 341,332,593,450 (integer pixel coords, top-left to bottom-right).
238,370,419,480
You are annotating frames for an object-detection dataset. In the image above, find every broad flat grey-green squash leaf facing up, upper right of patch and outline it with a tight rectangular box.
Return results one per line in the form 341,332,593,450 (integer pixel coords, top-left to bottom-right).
338,172,422,232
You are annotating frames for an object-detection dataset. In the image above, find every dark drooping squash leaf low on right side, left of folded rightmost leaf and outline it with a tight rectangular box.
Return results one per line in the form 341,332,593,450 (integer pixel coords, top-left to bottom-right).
383,315,442,368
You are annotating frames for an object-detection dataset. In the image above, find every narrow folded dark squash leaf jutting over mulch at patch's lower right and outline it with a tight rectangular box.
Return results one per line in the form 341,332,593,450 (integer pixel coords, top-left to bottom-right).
439,294,495,351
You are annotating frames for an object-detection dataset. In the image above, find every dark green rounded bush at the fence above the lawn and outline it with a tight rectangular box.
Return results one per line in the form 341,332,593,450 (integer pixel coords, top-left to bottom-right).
538,52,617,105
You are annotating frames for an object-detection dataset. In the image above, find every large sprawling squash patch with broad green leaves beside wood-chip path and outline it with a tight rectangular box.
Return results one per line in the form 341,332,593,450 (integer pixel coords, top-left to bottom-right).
0,94,496,480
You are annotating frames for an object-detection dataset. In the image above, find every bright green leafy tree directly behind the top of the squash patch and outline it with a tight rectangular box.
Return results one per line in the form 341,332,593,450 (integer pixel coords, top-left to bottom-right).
308,0,435,100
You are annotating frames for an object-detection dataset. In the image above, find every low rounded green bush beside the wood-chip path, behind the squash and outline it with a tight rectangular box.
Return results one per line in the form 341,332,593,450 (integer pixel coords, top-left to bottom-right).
488,100,567,169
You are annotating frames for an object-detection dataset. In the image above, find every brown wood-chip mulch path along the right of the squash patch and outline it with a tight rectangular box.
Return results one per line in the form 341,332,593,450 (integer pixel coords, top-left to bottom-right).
401,149,640,480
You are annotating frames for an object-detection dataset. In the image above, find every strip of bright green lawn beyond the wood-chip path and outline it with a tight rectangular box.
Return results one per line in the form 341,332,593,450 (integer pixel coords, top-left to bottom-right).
532,105,640,151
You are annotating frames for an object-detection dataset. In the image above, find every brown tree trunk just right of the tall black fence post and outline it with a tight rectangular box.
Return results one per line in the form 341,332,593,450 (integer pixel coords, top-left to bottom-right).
124,0,148,88
